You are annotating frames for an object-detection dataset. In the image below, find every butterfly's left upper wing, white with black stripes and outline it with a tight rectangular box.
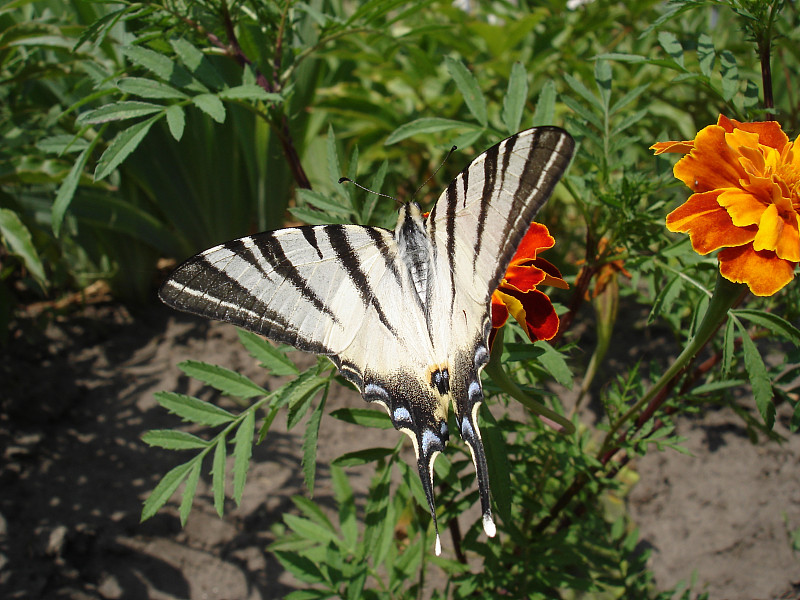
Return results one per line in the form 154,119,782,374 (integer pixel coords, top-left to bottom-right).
159,225,425,380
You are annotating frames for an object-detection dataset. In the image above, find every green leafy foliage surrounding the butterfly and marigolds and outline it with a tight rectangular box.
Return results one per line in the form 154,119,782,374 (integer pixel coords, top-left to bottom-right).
0,0,800,599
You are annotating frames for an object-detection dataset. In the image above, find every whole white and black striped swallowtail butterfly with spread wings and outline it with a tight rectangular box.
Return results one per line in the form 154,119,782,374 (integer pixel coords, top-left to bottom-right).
159,127,574,554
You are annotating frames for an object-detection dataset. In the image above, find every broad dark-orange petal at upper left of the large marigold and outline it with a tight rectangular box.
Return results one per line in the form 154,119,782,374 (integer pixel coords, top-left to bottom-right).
673,125,747,192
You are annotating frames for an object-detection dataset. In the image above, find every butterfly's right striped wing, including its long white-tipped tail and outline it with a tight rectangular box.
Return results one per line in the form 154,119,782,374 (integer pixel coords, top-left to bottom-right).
427,127,574,535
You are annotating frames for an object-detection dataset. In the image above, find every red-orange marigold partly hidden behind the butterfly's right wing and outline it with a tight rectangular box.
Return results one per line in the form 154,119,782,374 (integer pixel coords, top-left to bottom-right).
489,223,568,347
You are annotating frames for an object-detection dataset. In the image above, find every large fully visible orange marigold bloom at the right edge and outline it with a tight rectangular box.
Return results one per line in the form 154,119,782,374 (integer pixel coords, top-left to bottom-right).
651,115,800,296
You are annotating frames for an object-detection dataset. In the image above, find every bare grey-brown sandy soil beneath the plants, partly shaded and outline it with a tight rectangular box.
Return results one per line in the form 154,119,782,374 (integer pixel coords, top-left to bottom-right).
0,305,800,600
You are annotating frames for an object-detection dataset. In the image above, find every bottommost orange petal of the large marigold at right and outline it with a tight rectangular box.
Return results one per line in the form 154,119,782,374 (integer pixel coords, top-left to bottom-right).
718,244,797,296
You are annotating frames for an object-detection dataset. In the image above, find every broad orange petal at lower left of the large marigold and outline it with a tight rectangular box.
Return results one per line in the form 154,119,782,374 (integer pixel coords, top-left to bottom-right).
667,190,756,254
